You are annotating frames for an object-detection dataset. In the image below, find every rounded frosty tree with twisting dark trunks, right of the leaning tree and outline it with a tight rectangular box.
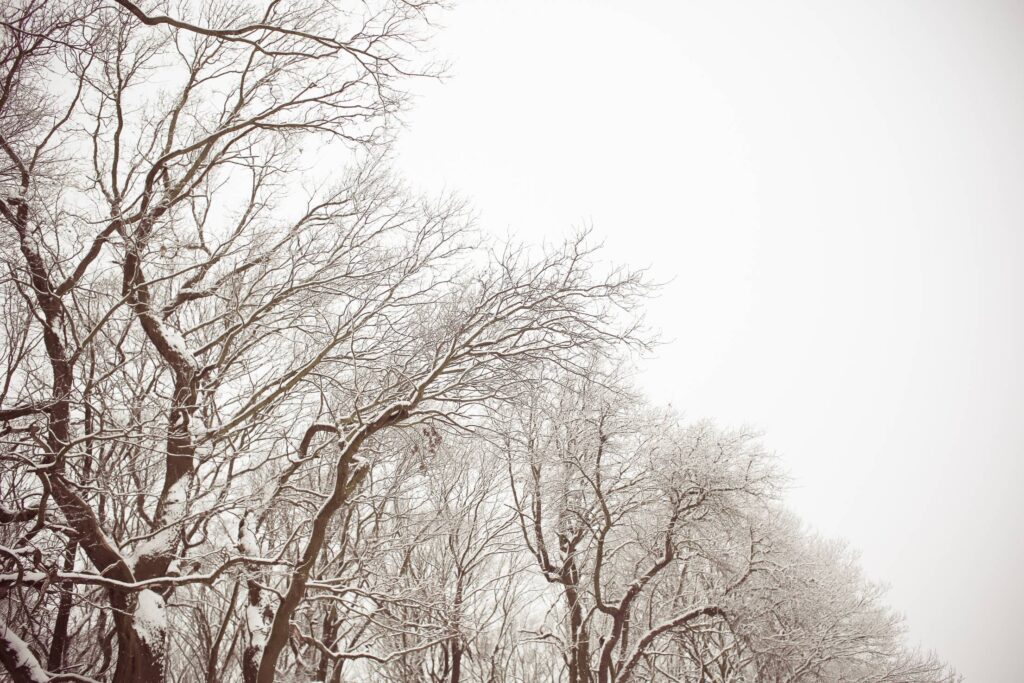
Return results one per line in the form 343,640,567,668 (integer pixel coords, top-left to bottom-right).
499,371,772,682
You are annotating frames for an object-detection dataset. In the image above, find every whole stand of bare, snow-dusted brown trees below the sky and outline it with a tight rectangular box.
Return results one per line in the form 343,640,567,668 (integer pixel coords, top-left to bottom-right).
0,0,959,683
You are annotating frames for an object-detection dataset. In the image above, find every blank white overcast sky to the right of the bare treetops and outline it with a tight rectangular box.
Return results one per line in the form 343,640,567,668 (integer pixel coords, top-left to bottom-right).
399,0,1024,682
